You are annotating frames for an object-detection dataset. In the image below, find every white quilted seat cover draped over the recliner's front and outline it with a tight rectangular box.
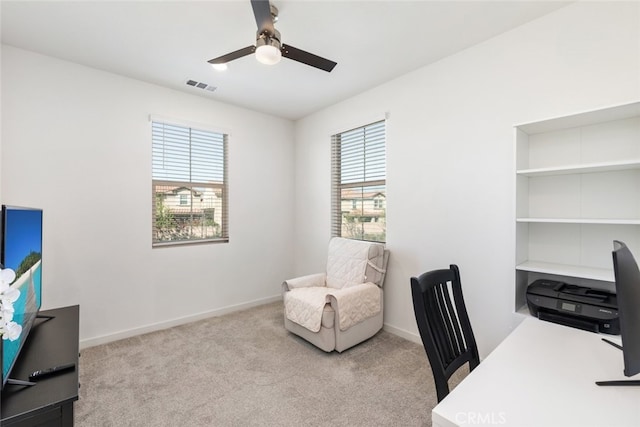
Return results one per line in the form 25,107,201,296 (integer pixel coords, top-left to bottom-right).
284,286,333,332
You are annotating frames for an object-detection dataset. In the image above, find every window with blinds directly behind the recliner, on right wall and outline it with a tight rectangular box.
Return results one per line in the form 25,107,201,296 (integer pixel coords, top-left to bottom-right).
331,120,387,242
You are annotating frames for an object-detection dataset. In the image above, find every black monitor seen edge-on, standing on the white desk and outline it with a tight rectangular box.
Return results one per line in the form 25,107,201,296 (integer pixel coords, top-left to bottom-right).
596,240,640,386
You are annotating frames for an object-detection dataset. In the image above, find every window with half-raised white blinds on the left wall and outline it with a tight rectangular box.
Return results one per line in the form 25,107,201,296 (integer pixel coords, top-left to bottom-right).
151,121,229,246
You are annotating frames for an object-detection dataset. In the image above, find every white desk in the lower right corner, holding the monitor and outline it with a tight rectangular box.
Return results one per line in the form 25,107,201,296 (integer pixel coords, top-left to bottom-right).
431,317,640,427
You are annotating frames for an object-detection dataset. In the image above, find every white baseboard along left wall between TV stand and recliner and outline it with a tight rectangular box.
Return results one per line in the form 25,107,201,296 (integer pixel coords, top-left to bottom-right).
80,295,282,350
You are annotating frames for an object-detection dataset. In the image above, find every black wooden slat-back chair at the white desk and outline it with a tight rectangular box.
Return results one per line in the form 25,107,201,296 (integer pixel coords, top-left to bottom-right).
411,264,480,402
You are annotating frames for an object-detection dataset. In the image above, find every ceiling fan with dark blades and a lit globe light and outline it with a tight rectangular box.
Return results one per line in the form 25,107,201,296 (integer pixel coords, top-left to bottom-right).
207,0,337,72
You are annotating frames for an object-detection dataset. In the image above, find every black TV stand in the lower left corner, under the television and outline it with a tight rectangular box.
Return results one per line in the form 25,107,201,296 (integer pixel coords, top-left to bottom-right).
0,305,80,427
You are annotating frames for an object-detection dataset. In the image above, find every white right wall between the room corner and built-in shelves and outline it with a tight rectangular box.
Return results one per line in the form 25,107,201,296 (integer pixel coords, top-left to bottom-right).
294,2,640,356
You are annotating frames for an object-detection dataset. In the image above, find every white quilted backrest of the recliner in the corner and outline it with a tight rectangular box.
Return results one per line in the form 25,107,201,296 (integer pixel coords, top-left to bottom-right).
326,237,386,289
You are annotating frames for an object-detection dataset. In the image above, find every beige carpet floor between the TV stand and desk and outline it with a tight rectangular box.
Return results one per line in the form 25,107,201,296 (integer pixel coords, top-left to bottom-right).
75,302,465,427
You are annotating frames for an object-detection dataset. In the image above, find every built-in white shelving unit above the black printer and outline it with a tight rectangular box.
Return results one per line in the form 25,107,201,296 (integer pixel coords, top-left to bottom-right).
515,102,640,312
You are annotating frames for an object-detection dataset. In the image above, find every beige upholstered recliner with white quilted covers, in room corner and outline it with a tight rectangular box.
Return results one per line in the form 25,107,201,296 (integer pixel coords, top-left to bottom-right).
282,237,389,352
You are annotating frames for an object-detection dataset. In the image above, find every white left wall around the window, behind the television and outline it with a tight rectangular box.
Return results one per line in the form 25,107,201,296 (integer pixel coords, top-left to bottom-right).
0,46,294,345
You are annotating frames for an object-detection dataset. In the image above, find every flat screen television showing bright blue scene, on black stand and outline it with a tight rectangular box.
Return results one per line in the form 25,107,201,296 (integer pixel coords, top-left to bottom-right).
0,205,42,388
